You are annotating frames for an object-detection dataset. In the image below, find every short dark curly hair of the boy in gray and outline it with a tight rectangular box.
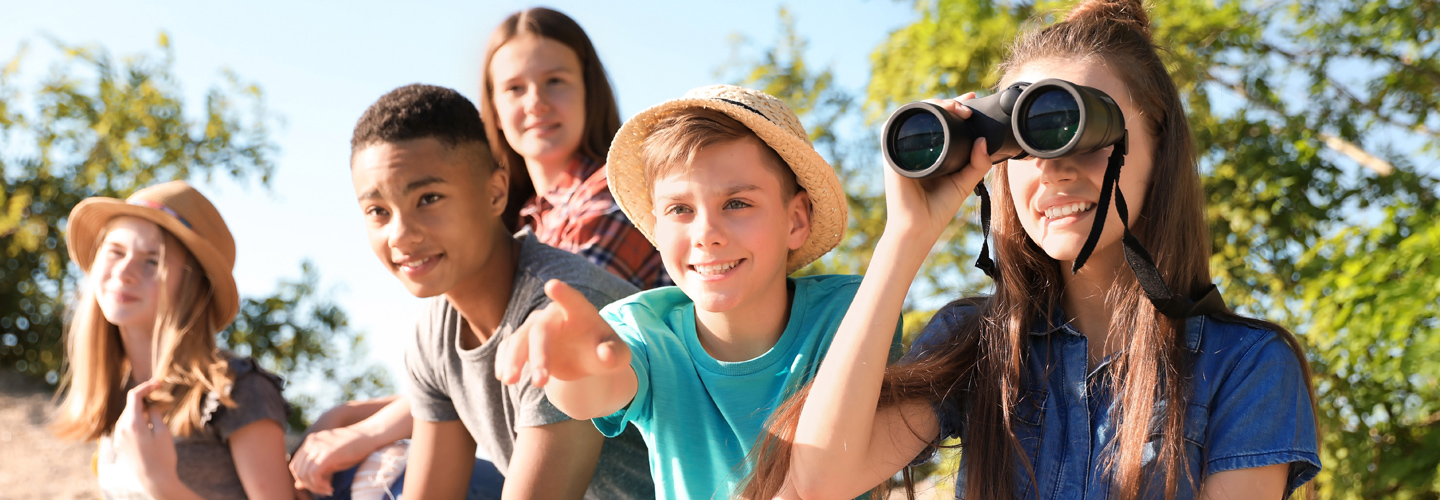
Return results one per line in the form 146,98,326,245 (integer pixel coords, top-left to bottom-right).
350,84,490,156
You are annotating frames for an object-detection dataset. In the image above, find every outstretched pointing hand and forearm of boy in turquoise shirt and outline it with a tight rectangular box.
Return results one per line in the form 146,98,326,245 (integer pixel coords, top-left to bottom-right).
495,280,638,419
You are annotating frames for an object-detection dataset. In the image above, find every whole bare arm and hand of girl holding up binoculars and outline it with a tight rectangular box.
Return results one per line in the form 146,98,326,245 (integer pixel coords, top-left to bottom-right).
789,94,991,499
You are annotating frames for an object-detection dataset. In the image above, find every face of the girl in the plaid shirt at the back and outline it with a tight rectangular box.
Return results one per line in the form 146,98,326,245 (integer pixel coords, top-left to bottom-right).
490,35,585,170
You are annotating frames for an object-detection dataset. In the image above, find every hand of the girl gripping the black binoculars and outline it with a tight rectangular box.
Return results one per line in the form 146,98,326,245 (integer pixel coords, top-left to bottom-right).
884,92,991,244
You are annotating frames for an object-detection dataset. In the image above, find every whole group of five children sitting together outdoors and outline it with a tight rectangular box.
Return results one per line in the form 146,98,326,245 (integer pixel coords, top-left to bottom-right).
55,0,1319,499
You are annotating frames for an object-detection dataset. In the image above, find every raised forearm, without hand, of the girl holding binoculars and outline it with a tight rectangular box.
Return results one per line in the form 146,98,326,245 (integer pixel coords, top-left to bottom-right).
791,231,929,484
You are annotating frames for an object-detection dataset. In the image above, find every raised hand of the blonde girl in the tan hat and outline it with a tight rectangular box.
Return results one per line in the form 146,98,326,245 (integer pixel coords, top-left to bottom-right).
114,379,180,497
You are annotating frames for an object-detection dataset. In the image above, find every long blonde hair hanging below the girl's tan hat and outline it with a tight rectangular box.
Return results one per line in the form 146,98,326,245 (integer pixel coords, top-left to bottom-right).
50,218,235,441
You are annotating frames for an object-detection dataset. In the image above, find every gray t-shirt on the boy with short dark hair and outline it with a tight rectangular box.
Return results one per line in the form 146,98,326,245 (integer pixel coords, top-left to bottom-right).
405,232,655,500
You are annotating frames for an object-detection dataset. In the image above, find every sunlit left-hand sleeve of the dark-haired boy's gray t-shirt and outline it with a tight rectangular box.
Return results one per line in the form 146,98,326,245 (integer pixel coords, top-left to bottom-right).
405,300,459,422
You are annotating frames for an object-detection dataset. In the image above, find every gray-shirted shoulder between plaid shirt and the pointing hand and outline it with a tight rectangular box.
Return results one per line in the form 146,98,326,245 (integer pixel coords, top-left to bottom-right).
518,233,636,305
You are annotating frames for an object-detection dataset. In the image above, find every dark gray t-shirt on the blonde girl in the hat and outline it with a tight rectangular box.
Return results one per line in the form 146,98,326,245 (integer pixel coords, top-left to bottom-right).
95,352,289,500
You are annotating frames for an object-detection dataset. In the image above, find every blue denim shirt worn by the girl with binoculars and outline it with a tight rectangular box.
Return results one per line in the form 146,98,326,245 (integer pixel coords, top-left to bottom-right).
907,304,1320,499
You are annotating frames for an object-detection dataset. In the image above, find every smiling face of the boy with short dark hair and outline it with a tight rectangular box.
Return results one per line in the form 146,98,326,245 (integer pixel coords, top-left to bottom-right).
350,137,508,297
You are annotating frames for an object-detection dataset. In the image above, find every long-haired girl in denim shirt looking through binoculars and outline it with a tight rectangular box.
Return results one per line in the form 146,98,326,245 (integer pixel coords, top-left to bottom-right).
743,0,1319,499
